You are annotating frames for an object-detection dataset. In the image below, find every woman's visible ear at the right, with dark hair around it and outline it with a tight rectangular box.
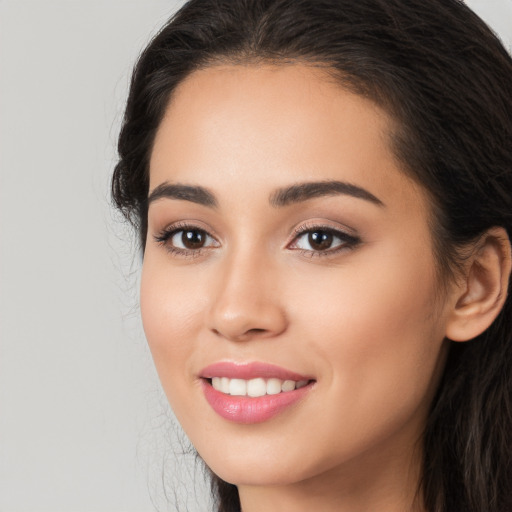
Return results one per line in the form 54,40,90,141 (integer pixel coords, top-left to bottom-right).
446,227,512,341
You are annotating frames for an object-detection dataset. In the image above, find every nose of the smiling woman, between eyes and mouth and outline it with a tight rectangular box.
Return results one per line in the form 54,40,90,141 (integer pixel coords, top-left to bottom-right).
208,249,287,341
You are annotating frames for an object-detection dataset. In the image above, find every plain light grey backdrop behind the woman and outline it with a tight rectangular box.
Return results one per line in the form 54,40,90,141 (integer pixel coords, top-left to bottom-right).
0,0,512,512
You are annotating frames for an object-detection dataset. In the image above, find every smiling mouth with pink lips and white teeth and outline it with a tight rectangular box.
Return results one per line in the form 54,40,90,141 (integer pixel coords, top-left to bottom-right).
200,362,316,424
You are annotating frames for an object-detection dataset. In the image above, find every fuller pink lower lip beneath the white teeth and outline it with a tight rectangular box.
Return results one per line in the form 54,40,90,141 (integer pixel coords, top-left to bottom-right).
202,380,312,424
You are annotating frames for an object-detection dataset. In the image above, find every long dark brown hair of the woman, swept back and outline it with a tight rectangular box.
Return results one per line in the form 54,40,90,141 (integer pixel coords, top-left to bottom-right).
112,0,512,512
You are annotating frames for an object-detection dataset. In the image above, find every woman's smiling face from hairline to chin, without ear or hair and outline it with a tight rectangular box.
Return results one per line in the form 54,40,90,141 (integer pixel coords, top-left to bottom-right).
141,65,449,492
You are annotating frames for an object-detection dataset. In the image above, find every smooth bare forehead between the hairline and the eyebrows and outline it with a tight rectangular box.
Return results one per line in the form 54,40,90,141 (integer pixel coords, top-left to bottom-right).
150,64,424,210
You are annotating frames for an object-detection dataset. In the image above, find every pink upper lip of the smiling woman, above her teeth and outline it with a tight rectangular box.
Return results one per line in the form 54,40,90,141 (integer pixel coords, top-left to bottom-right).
199,361,312,381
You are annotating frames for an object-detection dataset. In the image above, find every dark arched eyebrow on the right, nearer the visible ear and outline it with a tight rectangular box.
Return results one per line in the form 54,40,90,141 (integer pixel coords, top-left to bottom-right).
270,181,384,207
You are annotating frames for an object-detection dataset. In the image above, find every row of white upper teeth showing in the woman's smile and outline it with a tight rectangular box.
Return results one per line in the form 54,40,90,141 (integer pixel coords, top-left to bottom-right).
212,377,309,398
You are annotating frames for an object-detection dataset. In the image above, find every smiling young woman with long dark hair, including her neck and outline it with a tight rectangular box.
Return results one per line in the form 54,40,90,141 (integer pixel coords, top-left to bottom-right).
113,0,512,512
